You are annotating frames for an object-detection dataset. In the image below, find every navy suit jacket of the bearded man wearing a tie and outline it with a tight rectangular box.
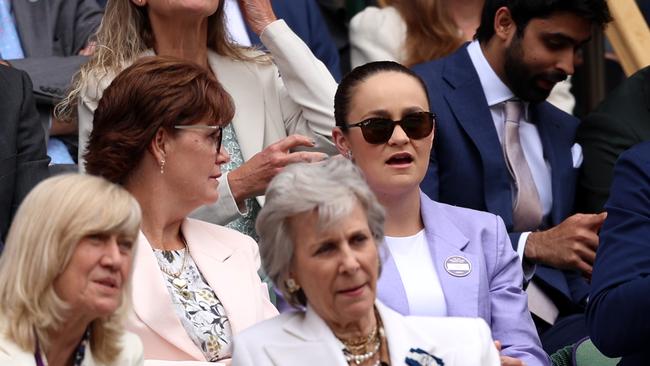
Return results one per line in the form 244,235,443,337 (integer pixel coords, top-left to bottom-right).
413,46,589,309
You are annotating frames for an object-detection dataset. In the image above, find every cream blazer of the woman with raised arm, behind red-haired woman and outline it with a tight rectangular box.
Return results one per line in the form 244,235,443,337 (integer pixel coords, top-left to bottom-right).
78,20,338,225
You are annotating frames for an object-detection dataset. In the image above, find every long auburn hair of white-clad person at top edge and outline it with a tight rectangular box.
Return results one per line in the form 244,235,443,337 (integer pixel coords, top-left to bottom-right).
379,0,463,66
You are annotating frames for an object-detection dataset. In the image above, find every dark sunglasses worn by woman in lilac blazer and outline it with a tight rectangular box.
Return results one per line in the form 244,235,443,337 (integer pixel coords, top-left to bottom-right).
344,112,436,144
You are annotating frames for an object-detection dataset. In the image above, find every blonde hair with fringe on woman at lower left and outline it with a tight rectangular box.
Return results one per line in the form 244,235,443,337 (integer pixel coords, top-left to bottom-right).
0,174,141,363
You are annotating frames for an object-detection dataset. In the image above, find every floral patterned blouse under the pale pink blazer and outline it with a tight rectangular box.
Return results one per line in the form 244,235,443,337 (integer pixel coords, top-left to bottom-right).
154,249,232,362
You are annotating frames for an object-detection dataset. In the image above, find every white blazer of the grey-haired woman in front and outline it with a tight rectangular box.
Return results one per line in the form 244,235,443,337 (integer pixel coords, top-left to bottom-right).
232,301,500,366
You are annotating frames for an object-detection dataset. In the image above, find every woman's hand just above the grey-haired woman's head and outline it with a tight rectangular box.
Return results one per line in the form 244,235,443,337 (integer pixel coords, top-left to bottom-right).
228,135,327,207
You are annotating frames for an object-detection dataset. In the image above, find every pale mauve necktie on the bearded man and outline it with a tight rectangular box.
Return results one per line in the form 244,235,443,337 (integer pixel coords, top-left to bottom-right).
504,100,542,231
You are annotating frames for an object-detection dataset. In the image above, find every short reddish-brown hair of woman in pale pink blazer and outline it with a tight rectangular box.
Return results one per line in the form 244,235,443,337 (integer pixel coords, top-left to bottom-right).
84,56,235,184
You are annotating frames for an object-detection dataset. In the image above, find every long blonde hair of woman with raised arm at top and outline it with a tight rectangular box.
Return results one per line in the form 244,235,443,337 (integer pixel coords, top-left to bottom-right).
55,0,256,120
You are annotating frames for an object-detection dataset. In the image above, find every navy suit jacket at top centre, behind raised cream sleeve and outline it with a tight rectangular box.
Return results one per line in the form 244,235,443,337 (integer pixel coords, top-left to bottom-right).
246,0,341,82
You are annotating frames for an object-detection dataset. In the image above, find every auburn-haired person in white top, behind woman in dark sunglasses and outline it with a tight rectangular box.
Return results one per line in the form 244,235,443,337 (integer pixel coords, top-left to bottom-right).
350,0,575,114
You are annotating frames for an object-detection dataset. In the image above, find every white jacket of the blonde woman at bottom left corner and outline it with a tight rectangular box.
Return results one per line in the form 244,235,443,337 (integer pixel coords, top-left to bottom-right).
0,332,144,366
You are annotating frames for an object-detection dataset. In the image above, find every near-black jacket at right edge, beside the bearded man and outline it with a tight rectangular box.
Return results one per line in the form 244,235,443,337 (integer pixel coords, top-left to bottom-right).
576,66,650,212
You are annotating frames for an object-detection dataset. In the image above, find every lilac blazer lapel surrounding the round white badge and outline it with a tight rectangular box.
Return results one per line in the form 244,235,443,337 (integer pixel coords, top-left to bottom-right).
420,192,480,317
